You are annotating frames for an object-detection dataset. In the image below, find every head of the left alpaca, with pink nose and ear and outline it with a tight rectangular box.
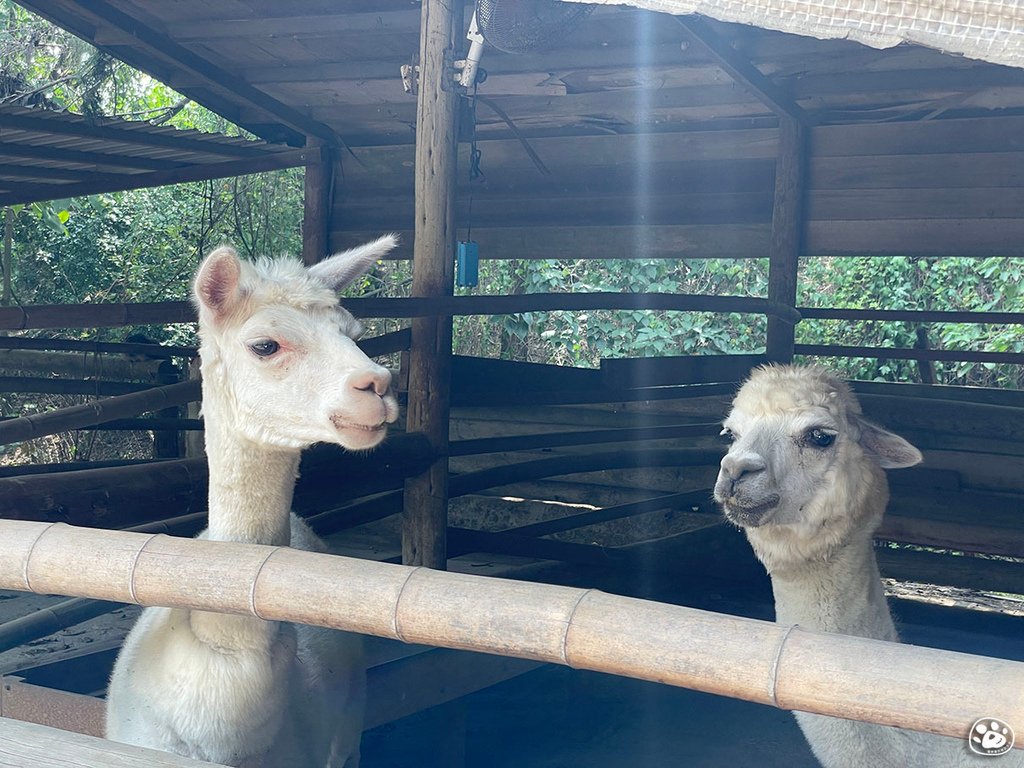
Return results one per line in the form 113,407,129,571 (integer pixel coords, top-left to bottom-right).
194,234,397,450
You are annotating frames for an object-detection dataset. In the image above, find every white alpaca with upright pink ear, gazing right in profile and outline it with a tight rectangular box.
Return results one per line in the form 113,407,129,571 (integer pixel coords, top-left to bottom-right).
106,236,397,768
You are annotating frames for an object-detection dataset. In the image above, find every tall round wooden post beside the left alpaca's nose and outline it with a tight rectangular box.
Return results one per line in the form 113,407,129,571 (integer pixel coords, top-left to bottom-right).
401,0,462,568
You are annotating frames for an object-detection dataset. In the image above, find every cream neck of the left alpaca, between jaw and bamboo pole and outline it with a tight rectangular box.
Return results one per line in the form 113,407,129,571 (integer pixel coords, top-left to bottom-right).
199,415,300,546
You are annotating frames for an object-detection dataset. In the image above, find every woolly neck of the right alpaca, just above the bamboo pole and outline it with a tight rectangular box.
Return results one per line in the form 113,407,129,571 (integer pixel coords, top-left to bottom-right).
771,536,899,641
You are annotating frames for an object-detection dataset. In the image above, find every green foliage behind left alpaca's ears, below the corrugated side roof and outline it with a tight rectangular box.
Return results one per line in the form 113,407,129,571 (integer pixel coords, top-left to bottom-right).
12,169,303,343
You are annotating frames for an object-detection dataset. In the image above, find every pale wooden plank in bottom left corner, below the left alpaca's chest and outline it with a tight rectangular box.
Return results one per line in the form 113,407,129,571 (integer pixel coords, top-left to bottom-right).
0,718,221,768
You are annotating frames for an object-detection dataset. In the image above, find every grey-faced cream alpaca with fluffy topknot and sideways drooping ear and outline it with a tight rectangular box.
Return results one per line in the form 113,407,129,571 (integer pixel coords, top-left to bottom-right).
715,366,1024,768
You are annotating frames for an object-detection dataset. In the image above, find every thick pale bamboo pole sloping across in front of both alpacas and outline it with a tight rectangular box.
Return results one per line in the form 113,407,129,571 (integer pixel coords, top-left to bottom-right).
0,520,1024,746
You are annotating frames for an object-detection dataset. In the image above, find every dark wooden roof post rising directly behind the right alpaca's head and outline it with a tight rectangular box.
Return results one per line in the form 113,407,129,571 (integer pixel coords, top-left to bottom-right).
767,116,807,362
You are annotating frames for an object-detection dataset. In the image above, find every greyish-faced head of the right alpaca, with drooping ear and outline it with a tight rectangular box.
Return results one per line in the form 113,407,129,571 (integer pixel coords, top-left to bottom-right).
715,366,922,571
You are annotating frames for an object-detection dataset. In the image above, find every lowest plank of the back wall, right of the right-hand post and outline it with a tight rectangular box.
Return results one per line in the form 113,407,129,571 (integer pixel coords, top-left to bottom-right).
802,219,1024,256
